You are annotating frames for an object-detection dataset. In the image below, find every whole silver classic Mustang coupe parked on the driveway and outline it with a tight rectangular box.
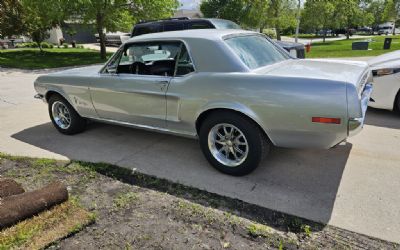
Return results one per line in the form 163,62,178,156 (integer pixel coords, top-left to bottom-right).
34,29,372,175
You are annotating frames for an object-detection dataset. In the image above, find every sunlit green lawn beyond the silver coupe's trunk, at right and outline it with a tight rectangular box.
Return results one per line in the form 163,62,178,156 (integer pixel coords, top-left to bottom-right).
306,36,400,58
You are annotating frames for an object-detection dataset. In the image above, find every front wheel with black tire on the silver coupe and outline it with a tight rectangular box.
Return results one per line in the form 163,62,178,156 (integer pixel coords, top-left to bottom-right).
48,95,86,135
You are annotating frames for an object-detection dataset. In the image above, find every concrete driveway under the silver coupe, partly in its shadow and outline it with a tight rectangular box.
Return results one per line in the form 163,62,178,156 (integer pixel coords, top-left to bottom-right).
0,69,400,243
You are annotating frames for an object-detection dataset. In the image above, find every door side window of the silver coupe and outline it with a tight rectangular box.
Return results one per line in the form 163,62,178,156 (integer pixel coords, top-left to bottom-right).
117,41,181,76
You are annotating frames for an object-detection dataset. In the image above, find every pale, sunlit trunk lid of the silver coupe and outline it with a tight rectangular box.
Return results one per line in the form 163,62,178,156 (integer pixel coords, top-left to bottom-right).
254,59,368,85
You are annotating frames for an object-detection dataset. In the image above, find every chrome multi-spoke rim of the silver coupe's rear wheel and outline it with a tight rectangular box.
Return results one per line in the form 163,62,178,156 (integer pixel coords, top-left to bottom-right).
208,123,249,167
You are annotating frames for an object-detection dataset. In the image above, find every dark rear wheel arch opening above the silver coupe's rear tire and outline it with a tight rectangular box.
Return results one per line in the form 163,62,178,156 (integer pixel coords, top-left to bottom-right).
195,107,275,145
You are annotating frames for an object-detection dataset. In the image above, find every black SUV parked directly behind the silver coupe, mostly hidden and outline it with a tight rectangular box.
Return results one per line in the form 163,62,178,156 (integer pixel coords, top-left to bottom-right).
131,17,305,58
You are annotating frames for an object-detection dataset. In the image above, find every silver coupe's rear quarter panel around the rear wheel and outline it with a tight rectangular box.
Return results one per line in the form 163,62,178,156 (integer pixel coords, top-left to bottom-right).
167,73,348,148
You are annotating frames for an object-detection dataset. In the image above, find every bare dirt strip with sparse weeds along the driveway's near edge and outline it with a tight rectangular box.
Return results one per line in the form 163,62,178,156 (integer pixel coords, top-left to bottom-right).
0,155,398,249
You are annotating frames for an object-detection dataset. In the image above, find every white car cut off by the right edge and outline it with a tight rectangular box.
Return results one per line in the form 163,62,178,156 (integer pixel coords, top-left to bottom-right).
368,50,400,111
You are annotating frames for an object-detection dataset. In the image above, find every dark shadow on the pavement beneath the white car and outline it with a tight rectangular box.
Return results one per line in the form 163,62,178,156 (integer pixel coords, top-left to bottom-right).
365,107,400,129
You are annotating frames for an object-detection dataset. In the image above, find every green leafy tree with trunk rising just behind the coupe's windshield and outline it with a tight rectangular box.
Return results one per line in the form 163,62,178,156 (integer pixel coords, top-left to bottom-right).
76,0,178,59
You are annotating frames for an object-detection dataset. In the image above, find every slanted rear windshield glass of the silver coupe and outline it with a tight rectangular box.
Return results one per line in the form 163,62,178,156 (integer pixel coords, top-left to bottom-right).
225,35,290,69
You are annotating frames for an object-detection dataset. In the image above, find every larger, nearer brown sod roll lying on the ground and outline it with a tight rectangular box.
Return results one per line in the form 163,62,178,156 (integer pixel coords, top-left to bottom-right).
0,182,68,229
